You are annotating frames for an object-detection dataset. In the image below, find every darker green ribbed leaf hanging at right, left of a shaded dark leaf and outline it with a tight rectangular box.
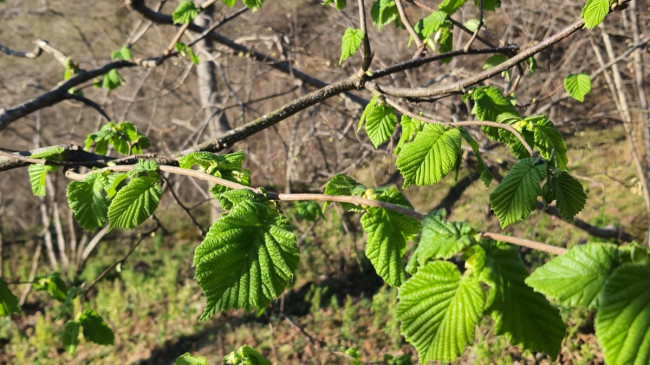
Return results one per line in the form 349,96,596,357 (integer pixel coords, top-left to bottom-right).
490,158,546,228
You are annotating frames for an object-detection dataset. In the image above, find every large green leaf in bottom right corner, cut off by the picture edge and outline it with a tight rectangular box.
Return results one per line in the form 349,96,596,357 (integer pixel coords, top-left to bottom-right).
595,265,650,365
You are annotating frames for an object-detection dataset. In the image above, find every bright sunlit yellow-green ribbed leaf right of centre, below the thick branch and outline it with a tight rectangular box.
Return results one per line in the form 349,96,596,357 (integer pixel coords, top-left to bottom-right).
396,124,461,187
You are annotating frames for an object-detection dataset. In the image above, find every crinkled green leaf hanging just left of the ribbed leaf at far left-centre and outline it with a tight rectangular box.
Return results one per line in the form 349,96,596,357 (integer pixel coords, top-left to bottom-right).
67,173,109,231
